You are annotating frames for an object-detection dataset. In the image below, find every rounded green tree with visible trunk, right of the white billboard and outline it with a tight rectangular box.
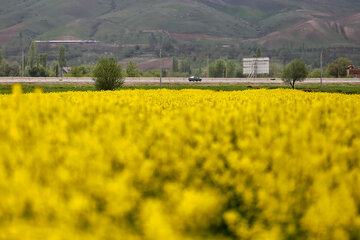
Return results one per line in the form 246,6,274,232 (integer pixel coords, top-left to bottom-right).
282,59,309,89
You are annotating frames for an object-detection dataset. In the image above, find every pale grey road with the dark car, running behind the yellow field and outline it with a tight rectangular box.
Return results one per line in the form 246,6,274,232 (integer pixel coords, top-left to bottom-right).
0,77,360,85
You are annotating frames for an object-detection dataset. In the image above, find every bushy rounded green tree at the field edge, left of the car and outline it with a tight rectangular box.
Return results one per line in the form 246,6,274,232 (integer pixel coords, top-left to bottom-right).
93,57,124,90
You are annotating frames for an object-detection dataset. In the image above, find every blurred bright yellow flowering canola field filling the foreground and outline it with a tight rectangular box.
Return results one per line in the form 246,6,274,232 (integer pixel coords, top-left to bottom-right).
0,89,360,240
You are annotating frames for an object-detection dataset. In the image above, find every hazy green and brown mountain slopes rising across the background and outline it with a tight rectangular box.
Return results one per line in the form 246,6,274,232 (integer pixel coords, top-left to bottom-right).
0,0,360,48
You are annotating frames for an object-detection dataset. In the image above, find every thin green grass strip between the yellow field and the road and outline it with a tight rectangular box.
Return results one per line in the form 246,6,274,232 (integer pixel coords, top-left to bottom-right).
0,84,360,94
